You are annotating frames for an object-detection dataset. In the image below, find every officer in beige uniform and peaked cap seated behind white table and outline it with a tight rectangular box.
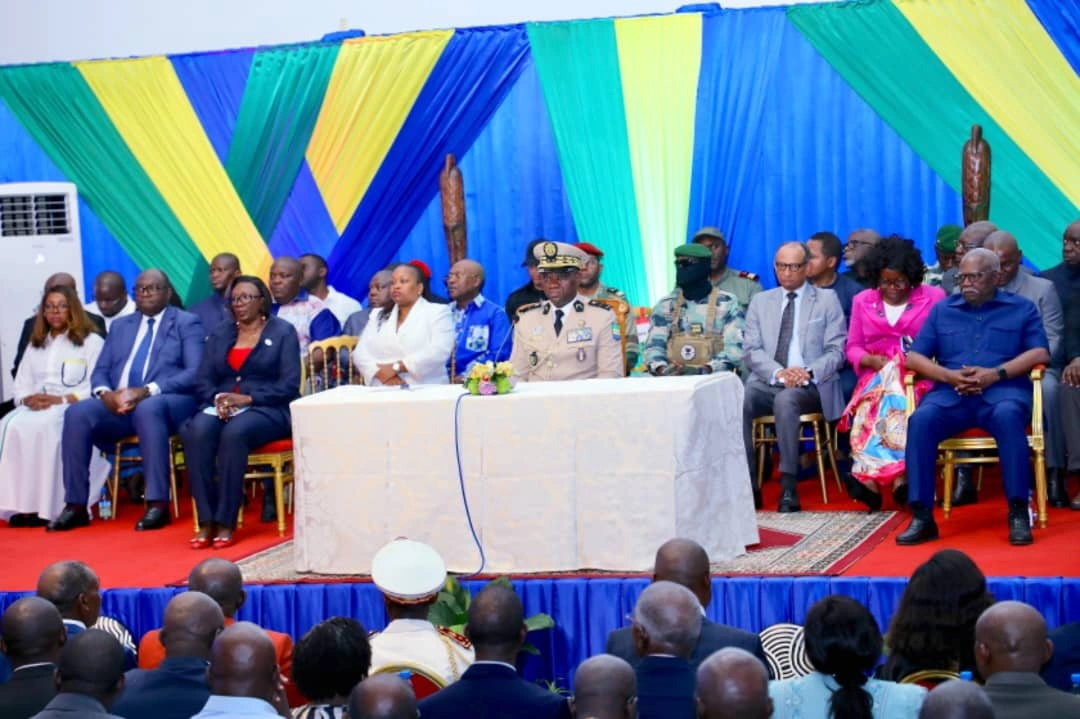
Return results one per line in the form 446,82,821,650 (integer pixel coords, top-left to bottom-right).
510,242,623,382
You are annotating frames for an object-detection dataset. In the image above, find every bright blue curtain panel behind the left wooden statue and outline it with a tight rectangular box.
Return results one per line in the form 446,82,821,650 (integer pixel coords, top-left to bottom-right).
395,56,578,303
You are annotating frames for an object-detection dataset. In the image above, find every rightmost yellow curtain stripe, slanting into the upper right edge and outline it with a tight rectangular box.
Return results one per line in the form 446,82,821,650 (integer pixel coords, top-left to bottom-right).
894,0,1080,206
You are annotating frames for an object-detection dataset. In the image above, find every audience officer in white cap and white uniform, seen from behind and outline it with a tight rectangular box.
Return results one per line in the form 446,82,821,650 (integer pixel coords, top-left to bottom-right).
370,539,475,684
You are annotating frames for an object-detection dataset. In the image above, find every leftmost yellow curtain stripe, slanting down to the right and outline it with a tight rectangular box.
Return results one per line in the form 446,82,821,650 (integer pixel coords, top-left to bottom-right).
75,57,270,276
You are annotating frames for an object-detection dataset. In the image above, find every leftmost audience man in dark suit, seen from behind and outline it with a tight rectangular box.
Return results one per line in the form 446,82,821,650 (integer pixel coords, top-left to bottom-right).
0,597,67,719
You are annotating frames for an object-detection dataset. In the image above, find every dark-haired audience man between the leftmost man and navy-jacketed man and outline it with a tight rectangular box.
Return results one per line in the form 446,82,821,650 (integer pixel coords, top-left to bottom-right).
35,629,124,719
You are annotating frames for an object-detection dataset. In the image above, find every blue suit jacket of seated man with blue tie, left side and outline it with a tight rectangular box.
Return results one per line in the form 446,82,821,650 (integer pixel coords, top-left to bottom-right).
90,307,205,394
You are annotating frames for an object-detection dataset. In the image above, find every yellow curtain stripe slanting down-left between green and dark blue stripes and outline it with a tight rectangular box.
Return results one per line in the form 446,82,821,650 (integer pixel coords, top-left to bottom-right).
307,30,454,233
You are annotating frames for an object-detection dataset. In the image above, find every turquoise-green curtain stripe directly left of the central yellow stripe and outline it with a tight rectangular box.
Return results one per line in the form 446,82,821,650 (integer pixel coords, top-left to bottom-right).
526,19,651,304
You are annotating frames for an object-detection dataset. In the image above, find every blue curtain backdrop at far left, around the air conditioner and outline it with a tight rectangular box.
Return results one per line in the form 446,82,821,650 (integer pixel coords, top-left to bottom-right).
0,99,139,295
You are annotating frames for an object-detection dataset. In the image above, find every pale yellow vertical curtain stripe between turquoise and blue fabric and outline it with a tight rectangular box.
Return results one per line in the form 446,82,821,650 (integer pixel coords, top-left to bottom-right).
615,13,701,298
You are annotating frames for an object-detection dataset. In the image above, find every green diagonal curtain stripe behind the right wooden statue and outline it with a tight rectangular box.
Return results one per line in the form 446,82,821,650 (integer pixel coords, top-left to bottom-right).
787,0,1078,268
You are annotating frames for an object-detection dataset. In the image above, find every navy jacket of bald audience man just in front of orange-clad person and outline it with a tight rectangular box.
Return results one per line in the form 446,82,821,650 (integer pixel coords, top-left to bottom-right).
109,656,210,719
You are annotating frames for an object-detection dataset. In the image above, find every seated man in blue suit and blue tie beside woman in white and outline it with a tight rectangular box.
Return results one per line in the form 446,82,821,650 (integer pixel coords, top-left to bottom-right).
46,270,206,531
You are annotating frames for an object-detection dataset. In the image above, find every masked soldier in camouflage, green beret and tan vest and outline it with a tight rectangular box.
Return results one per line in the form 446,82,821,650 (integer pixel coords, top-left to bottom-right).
645,244,744,376
